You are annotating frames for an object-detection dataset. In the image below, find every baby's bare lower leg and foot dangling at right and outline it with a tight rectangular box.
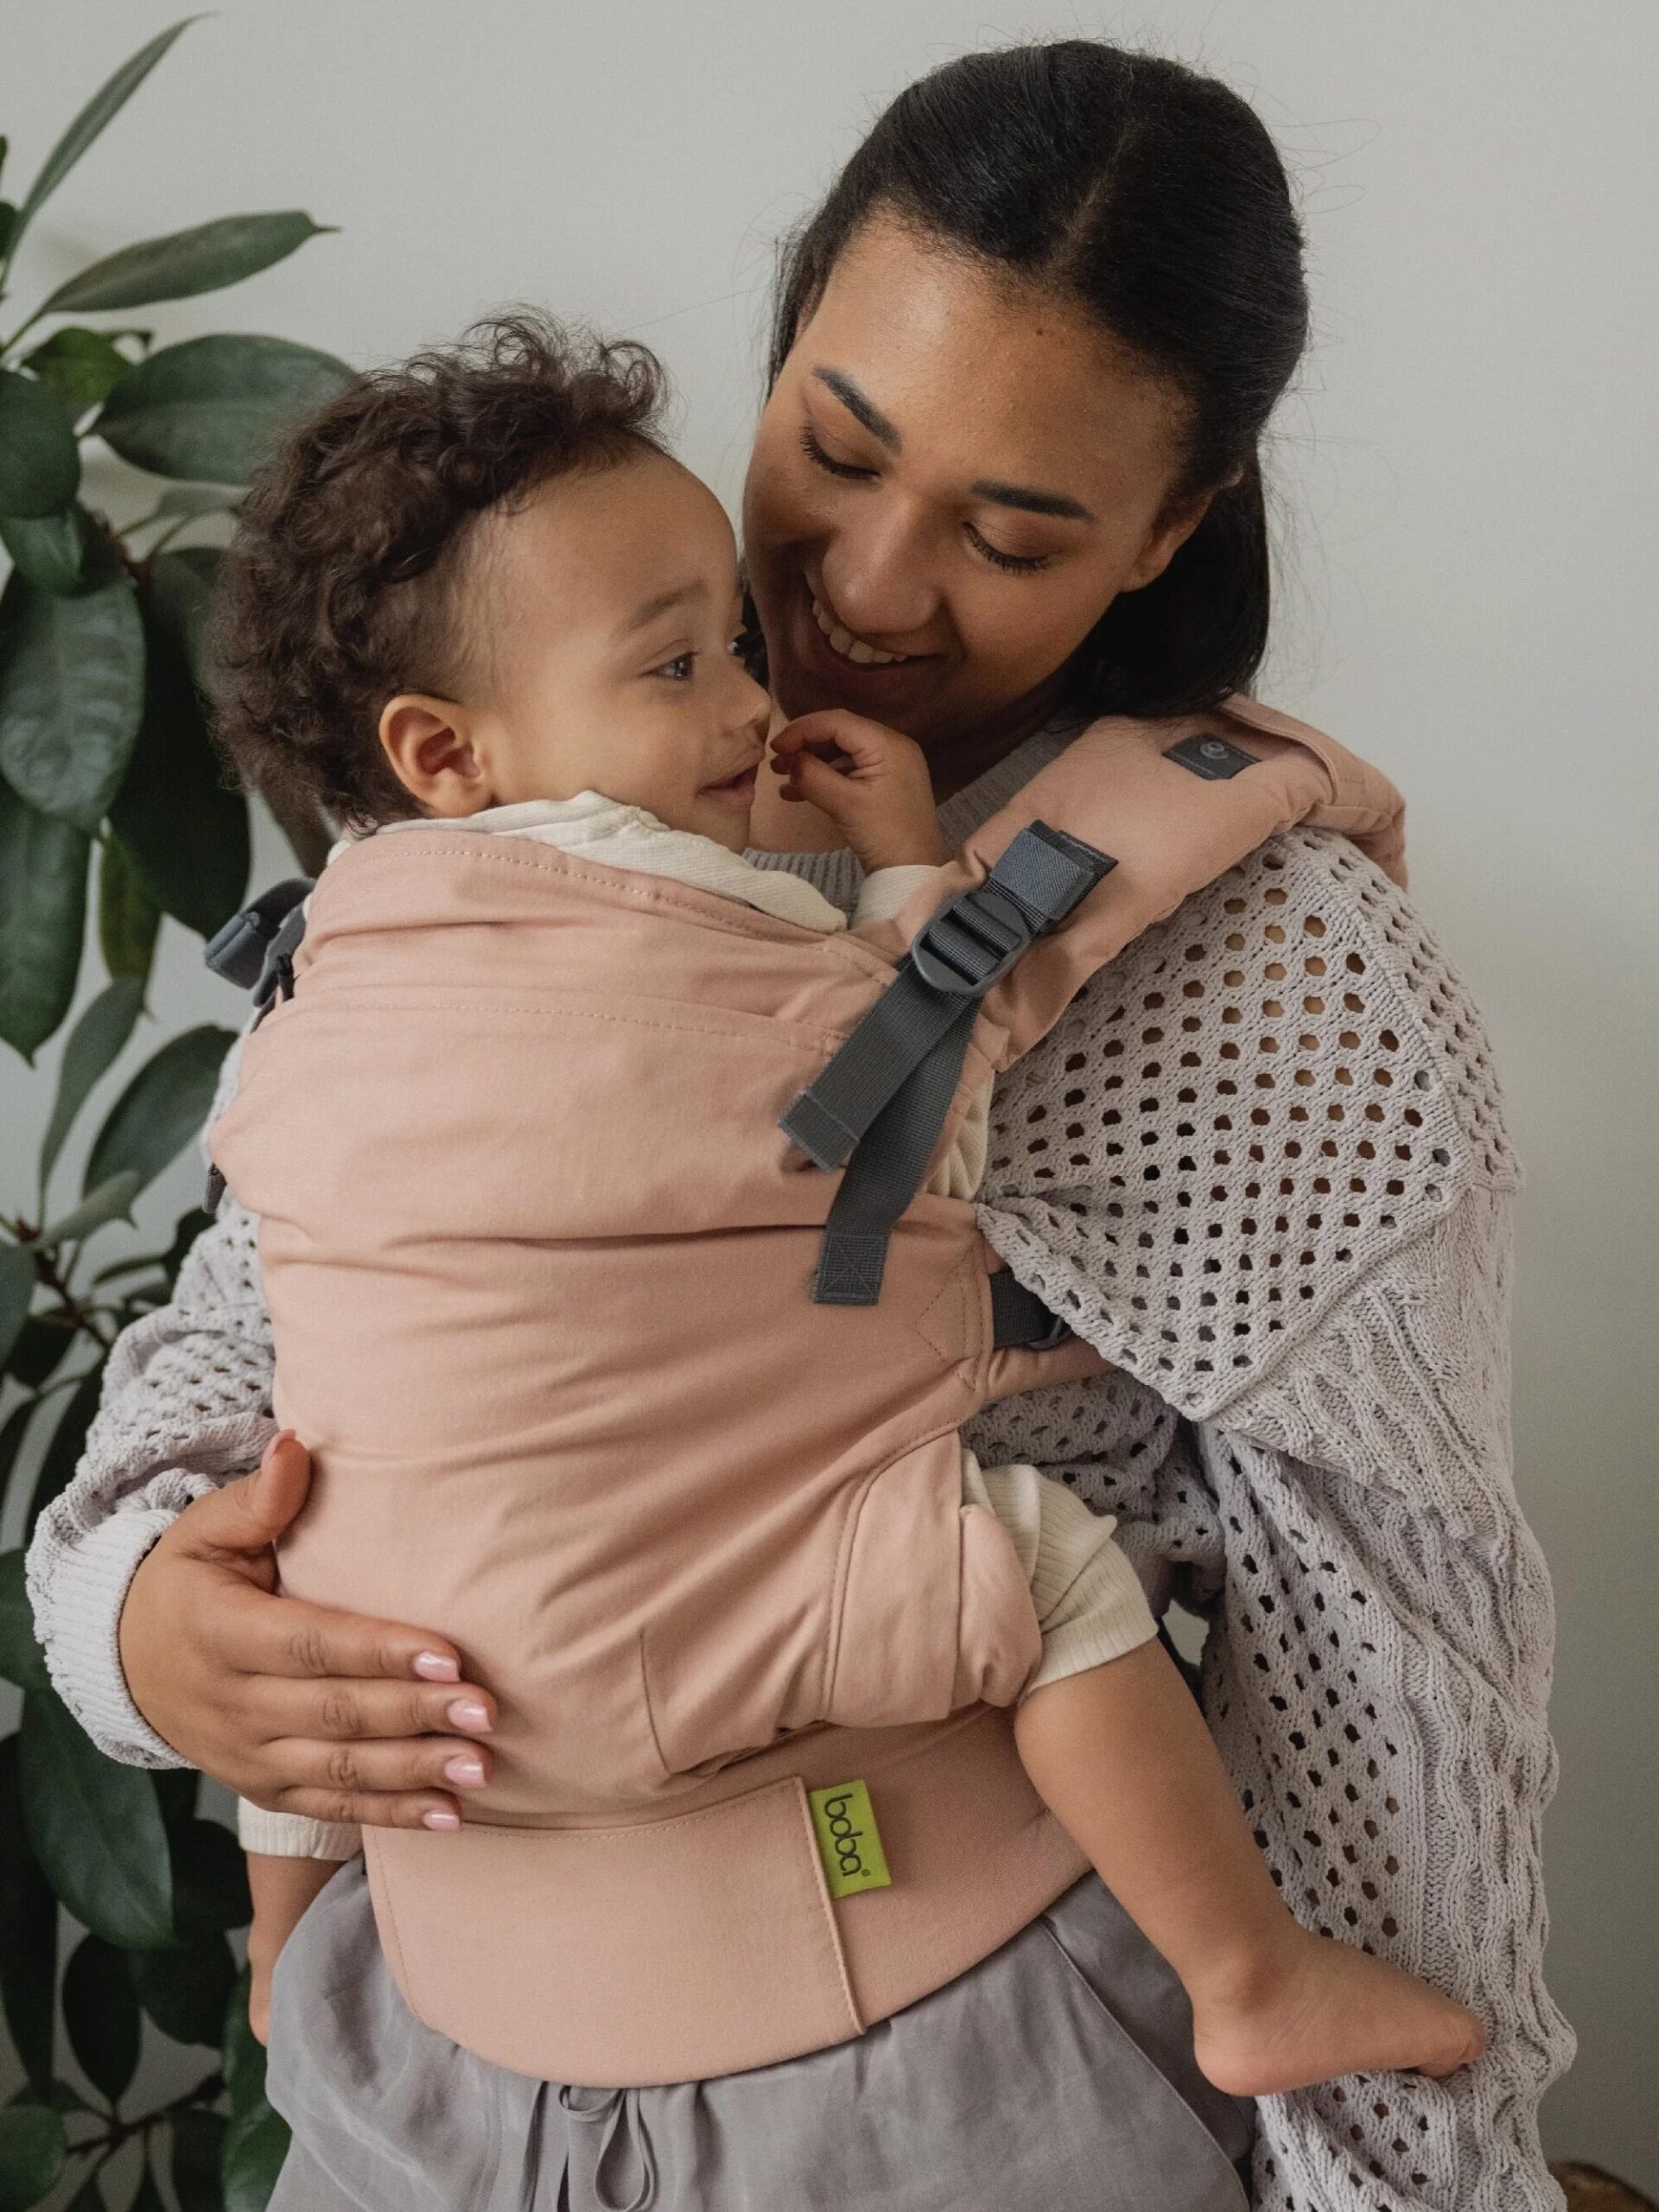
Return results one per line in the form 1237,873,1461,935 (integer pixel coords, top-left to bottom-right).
1015,1643,1484,2097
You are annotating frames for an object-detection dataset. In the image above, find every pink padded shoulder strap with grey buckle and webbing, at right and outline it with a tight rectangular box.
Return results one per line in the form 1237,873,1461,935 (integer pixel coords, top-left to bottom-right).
781,699,1405,1300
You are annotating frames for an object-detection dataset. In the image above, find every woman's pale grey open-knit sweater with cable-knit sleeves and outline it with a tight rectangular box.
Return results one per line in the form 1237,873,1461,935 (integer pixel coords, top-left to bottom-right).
31,736,1573,2212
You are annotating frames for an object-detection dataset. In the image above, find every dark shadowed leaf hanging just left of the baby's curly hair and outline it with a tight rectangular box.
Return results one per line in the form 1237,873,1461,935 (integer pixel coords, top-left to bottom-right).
111,566,250,938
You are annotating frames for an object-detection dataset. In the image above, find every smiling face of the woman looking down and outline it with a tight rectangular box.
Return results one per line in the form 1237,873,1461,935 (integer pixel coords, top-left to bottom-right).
743,217,1208,790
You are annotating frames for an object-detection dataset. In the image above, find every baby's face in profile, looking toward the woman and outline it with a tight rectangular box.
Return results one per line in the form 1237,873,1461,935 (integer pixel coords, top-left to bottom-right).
442,451,770,852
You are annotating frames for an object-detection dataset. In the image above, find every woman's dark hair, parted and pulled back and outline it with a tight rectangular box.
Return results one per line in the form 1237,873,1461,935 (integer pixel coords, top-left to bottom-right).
770,40,1307,715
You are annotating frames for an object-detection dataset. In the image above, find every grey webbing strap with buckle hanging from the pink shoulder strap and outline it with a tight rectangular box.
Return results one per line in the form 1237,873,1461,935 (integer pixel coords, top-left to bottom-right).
781,823,1117,1305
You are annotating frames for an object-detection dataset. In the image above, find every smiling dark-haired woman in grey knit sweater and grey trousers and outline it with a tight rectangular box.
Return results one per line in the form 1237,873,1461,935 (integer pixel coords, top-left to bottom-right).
33,42,1571,2212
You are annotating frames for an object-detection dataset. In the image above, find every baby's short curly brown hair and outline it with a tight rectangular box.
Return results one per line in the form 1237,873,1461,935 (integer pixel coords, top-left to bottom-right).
213,312,668,827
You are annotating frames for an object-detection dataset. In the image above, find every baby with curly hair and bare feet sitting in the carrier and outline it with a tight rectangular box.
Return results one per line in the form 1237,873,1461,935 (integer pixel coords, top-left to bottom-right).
221,321,1482,2094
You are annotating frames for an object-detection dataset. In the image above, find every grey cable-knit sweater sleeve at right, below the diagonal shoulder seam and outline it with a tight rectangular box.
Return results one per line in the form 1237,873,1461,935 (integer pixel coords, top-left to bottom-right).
1201,1192,1573,2212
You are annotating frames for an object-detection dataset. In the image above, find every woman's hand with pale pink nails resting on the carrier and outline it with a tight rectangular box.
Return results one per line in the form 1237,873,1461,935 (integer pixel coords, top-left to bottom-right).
119,1431,495,1829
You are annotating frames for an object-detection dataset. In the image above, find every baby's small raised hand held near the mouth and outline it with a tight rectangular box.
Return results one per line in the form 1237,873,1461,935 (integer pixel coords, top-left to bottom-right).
772,708,947,872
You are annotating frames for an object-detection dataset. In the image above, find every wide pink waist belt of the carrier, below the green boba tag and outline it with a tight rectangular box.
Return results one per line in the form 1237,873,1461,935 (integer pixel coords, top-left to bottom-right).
365,1707,1086,2088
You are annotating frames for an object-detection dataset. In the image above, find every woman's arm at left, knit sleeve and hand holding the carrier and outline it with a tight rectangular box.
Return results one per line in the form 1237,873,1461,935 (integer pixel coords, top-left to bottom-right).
29,1201,493,1827
